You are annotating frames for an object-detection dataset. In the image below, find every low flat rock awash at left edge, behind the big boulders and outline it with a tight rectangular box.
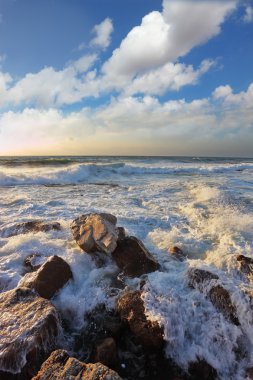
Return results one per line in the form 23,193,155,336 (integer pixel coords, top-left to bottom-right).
0,220,61,238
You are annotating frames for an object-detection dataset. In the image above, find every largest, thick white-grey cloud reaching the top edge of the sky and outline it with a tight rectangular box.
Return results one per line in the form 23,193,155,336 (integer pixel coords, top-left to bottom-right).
103,0,236,77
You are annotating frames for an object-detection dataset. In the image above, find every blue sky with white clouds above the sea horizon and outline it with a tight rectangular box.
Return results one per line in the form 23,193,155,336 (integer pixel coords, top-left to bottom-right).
0,0,253,157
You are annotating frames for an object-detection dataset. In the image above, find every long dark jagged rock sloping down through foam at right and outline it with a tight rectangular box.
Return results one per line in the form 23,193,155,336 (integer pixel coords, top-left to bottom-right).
188,268,240,326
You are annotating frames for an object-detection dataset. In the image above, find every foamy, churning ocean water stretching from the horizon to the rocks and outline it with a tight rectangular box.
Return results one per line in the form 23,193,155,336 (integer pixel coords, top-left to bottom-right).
0,157,253,380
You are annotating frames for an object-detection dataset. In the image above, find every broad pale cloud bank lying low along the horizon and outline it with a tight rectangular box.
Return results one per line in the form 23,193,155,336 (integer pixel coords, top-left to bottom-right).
0,83,253,155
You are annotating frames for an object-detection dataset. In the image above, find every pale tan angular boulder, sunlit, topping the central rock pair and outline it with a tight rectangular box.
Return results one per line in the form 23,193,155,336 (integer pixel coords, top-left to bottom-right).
71,213,118,254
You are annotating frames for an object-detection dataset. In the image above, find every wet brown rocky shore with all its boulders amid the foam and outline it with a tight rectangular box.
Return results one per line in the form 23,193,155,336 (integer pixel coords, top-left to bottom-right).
0,213,253,380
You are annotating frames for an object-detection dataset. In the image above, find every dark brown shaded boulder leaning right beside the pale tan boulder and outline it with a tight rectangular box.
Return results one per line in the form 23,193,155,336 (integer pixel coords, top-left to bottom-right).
112,236,160,277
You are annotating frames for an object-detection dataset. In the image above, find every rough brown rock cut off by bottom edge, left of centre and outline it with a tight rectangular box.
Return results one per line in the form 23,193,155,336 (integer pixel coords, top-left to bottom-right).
32,350,122,380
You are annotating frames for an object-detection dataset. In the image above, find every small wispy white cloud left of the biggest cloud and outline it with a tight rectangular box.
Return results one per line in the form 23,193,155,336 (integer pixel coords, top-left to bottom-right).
90,18,113,50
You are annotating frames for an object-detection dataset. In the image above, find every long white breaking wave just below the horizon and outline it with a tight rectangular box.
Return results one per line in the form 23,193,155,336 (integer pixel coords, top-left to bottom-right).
0,162,253,186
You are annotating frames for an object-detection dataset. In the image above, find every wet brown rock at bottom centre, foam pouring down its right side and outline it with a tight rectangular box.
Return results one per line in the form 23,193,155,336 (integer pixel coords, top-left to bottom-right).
117,291,164,350
